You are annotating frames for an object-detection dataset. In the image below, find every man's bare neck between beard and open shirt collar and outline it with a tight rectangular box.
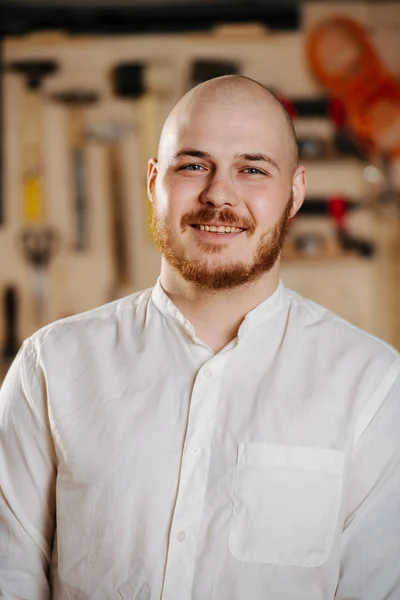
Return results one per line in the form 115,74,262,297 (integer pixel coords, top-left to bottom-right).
160,260,279,352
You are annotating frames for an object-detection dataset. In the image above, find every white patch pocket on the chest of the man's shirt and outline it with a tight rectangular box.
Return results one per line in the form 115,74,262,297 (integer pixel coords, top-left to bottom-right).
229,442,344,567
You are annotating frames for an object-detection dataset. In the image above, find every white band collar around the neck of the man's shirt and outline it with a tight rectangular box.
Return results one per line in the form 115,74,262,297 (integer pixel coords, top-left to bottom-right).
151,277,289,339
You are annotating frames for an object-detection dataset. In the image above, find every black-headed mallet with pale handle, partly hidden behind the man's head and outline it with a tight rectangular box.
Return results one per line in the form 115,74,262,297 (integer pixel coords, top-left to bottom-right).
111,62,174,239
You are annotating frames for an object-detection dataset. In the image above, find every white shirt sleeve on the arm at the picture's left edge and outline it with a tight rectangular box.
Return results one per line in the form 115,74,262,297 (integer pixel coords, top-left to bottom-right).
0,342,57,600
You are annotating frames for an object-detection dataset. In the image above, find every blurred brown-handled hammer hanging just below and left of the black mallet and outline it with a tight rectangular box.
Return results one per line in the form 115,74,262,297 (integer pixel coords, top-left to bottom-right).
88,122,133,301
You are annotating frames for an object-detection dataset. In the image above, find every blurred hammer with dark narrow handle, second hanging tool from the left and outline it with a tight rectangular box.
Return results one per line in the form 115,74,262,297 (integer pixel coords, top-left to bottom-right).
51,89,99,252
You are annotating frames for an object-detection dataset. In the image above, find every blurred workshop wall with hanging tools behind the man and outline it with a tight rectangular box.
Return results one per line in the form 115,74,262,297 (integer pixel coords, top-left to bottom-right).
0,0,400,381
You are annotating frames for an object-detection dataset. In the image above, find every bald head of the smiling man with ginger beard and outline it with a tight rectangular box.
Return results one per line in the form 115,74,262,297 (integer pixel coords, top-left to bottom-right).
148,75,305,290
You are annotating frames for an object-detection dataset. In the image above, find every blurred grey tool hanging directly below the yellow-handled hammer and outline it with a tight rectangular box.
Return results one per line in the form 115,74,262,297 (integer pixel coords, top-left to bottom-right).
19,226,60,328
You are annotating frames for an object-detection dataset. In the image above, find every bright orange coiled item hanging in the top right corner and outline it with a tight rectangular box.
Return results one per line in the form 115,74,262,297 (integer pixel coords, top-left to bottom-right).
307,16,400,156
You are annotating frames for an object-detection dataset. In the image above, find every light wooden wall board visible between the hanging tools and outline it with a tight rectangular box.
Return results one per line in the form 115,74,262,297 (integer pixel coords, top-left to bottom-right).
0,2,400,370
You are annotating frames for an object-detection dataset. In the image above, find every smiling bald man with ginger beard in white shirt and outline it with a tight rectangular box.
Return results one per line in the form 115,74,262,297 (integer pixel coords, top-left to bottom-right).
0,76,400,600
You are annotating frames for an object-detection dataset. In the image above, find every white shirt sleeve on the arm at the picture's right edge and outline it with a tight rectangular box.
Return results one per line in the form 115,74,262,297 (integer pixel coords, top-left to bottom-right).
335,365,400,600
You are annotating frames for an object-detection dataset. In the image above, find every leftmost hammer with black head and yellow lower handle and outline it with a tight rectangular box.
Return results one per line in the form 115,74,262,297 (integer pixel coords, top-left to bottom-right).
6,60,58,222
